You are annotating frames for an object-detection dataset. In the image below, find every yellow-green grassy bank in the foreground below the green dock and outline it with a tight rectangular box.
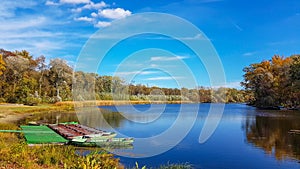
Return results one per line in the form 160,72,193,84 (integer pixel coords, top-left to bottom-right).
0,124,124,169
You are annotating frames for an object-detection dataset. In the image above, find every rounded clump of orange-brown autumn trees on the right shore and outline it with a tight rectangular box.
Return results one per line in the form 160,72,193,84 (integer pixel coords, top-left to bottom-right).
242,55,300,109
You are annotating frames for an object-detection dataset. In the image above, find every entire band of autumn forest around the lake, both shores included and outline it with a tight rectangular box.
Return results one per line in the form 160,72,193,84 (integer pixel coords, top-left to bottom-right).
0,49,300,107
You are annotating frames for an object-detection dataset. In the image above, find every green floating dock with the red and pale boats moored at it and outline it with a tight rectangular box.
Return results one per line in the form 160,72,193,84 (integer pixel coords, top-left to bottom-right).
0,123,134,148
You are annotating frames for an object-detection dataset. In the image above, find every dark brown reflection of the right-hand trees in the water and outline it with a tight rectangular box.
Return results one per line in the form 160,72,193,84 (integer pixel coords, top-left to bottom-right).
243,111,300,160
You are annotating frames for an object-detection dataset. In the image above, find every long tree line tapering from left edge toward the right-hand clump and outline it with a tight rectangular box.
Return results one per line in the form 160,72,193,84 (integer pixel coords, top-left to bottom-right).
0,49,252,104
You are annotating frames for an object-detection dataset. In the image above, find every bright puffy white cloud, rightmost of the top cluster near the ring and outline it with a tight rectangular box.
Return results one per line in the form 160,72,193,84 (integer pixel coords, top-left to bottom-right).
98,8,131,19
